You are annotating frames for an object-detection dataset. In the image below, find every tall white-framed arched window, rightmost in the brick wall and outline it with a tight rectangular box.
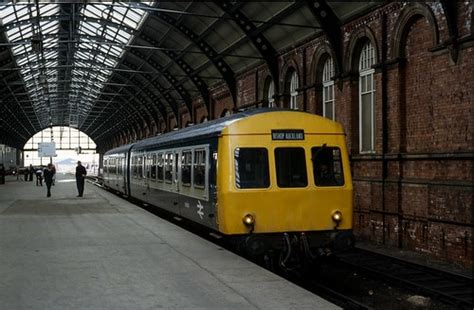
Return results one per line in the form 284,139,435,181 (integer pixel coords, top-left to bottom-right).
359,42,375,153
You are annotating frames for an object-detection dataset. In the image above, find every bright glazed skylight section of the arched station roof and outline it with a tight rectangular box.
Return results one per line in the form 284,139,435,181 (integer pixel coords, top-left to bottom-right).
0,1,152,126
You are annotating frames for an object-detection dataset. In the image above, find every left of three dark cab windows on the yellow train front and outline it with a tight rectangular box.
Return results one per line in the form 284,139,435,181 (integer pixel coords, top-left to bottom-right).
234,148,270,188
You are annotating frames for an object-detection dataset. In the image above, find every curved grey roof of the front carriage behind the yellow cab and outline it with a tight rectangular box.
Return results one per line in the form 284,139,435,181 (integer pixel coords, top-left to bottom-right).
133,108,282,150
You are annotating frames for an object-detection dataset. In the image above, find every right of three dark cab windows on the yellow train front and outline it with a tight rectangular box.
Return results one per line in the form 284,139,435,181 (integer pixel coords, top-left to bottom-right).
311,146,344,186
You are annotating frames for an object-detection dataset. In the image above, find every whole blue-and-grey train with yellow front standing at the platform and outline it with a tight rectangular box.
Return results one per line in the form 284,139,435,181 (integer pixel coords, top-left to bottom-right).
103,109,353,259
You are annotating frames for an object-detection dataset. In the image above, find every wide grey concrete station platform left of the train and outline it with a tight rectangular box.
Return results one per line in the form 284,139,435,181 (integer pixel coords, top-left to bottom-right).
0,175,338,310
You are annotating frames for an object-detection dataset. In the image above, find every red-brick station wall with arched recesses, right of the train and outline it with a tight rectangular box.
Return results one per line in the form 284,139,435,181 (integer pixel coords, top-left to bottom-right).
228,3,474,265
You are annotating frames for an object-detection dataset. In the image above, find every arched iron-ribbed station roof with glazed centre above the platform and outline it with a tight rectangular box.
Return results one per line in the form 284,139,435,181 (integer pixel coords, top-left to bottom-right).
0,1,383,148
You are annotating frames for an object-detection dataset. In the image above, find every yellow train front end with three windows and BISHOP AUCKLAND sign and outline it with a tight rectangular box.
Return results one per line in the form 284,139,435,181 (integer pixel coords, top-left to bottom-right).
216,111,354,257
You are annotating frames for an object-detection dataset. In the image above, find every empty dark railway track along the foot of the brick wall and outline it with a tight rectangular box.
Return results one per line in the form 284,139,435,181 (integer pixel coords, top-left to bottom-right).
338,248,474,309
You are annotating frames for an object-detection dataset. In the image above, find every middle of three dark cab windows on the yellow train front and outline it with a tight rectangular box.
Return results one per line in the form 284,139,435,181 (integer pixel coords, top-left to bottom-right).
275,147,308,187
